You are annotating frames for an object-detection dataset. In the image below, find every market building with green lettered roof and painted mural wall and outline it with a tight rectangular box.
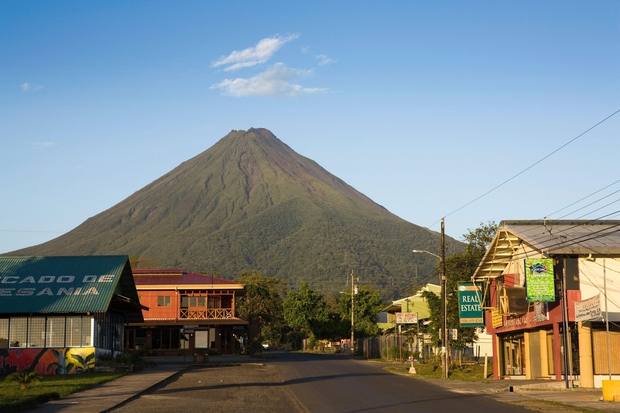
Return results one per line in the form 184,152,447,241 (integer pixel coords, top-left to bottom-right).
0,256,145,375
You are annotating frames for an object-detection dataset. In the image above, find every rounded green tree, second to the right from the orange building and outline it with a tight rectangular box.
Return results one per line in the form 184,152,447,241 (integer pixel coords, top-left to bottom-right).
284,282,330,339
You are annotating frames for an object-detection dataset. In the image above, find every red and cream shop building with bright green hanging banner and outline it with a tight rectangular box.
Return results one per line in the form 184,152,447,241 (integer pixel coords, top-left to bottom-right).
473,220,620,387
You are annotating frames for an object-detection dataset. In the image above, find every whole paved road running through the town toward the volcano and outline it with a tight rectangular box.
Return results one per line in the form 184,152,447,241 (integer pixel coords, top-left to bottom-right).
113,353,531,413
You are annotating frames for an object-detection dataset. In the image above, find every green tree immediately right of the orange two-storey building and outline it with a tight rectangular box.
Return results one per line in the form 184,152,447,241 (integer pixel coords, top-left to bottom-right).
237,271,286,353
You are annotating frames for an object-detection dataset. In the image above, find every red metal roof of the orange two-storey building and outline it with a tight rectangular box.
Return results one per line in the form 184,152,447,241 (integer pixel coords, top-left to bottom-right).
132,268,239,286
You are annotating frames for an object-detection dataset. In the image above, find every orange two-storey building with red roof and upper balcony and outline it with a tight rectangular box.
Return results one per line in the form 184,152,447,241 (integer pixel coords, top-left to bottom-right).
125,269,247,356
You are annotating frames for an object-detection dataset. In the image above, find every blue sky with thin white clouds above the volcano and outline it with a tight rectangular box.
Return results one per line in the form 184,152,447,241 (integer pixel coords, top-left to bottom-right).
0,0,620,253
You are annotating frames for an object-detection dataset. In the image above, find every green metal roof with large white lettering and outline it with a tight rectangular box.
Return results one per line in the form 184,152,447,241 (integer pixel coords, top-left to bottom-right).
0,256,141,318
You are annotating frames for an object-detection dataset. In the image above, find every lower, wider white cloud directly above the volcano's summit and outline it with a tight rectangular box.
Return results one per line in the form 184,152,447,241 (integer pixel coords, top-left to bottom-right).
211,63,327,97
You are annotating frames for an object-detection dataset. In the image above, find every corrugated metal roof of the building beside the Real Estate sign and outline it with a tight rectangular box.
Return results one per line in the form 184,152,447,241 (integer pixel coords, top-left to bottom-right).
474,220,620,279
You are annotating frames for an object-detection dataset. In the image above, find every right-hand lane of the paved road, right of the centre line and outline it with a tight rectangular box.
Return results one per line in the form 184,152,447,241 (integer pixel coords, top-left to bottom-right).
269,353,531,413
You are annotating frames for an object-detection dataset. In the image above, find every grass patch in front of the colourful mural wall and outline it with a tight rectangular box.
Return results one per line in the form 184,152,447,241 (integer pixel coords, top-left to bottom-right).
0,372,126,413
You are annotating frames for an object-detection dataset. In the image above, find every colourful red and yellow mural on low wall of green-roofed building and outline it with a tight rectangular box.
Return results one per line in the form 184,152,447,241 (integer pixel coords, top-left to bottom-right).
0,347,95,376
